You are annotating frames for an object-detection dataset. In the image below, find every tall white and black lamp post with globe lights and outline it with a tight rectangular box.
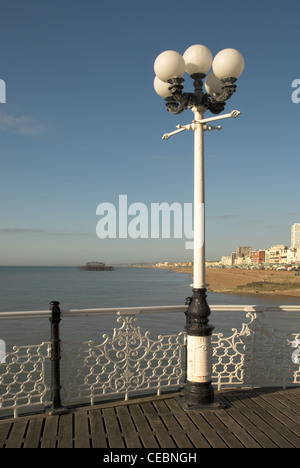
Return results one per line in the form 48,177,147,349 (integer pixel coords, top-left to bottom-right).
154,44,245,409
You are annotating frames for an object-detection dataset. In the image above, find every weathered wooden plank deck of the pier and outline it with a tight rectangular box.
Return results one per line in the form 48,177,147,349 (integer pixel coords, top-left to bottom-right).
0,388,300,449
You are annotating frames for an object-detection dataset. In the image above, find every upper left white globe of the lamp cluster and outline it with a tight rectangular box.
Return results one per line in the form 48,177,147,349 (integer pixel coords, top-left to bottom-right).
154,50,185,81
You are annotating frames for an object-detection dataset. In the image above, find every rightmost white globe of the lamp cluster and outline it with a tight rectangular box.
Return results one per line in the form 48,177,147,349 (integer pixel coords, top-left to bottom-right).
213,49,245,79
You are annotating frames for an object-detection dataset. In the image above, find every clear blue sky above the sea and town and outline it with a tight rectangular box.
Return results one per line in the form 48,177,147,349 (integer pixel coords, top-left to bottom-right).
0,0,300,265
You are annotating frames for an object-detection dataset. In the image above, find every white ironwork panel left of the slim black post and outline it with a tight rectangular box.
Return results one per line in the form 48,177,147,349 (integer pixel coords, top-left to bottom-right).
0,342,50,417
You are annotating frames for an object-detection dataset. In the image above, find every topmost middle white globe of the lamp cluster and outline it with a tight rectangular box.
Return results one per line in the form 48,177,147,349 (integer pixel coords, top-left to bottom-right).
183,44,213,75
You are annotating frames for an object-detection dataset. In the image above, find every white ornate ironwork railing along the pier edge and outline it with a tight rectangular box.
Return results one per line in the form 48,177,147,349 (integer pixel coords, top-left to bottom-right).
0,305,300,417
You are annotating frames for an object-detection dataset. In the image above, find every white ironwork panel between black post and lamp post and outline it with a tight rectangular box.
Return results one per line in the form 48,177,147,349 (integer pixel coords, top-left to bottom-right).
62,315,185,404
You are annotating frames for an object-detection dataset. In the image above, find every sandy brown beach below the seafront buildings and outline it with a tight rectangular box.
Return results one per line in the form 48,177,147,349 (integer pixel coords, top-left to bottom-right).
140,265,300,297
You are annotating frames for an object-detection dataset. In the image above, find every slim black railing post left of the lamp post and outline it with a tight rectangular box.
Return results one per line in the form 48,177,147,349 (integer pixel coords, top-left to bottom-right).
47,301,69,414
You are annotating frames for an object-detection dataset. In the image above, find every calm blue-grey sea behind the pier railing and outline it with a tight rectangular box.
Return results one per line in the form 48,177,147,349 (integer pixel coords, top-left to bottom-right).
0,266,300,351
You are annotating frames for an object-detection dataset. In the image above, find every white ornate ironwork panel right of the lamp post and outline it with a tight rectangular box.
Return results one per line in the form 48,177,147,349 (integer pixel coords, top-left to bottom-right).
212,312,300,389
